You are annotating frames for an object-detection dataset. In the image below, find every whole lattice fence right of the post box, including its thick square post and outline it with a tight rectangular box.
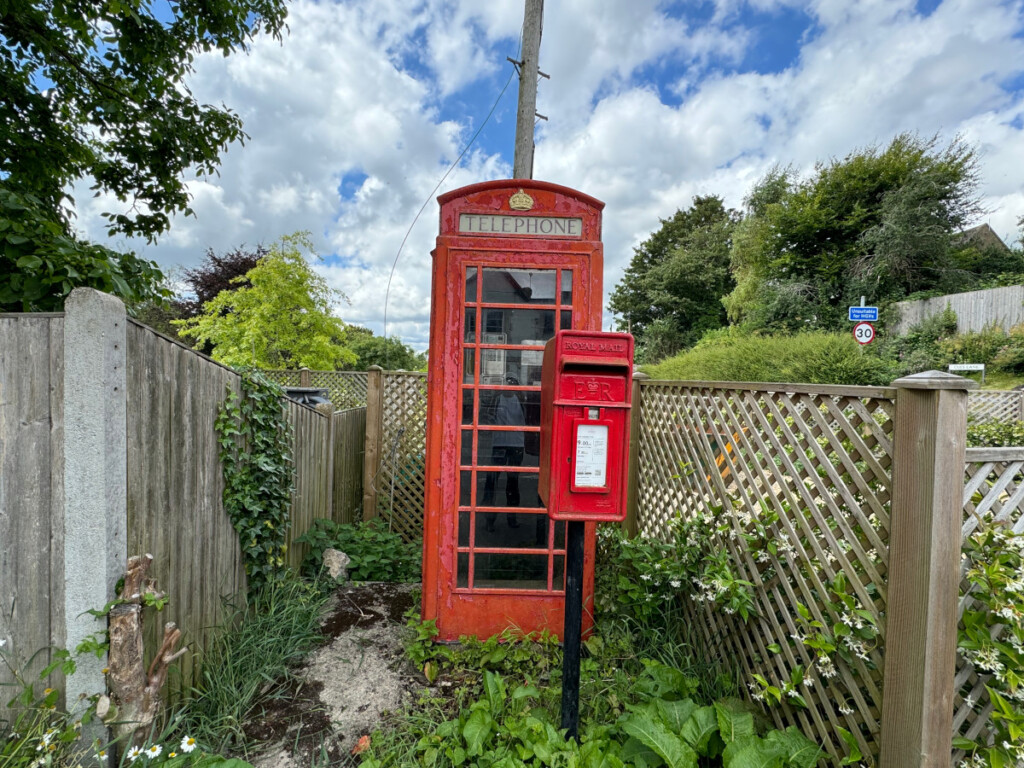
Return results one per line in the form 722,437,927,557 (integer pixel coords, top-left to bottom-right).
627,375,1024,766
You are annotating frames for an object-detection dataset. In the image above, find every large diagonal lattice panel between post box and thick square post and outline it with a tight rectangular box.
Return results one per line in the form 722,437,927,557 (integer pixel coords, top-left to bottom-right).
639,381,894,763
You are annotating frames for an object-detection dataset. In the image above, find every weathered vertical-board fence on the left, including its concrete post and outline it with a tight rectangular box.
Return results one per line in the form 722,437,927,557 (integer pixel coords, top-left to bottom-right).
0,290,366,703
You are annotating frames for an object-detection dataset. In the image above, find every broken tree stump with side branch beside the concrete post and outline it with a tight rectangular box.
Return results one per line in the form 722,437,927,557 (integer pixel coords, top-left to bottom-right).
108,554,188,744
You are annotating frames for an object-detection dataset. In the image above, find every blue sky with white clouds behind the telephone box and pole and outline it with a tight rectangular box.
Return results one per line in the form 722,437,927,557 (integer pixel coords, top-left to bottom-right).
77,0,1024,349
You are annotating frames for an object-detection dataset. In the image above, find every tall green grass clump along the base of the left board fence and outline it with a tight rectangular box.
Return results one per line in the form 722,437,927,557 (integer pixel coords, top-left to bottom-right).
179,578,329,752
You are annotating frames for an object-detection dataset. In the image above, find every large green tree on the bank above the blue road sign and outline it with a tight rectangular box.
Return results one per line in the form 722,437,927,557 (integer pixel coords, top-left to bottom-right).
725,134,981,331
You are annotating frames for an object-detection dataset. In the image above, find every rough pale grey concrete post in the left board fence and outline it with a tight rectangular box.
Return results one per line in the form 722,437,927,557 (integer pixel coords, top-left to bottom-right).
63,288,128,707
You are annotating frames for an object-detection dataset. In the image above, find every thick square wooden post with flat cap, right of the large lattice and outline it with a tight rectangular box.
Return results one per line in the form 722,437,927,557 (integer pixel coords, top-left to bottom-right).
879,371,977,768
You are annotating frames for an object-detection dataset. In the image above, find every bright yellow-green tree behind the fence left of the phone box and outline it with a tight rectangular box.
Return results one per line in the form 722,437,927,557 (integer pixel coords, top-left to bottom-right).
174,232,355,371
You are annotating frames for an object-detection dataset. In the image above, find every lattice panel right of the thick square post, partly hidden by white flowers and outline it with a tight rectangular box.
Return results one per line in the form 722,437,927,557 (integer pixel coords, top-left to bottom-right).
953,450,1024,759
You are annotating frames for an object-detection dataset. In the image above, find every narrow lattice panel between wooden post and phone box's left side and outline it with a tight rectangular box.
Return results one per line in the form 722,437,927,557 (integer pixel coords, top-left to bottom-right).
375,372,427,541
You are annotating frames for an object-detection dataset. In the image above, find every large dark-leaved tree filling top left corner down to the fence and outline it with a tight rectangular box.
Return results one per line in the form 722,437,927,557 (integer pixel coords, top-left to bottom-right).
0,0,286,310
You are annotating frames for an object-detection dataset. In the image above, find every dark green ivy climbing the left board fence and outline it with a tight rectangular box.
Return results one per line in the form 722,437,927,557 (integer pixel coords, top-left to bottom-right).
216,370,293,589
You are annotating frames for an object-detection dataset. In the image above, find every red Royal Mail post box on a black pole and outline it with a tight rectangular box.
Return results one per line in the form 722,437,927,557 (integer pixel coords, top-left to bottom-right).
539,331,633,522
